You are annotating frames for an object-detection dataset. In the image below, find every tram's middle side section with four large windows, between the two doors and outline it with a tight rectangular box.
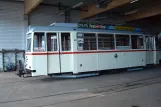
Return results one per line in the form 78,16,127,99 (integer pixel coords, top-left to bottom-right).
74,33,146,73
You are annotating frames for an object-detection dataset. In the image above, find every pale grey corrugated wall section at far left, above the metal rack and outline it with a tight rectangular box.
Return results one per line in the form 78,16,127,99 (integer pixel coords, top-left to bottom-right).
0,1,25,50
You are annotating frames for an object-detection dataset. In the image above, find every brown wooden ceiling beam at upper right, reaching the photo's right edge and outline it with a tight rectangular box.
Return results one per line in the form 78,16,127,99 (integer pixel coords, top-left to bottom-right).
123,5,161,22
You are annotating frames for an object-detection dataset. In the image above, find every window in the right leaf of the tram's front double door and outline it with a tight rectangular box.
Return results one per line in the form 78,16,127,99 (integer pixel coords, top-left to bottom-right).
61,33,71,51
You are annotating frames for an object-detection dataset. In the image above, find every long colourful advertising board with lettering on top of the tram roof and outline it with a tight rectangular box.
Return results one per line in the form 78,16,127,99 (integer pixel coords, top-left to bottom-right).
78,23,142,32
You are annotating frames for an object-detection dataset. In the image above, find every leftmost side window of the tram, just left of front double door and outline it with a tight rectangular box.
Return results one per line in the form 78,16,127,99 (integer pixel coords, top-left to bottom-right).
34,33,45,52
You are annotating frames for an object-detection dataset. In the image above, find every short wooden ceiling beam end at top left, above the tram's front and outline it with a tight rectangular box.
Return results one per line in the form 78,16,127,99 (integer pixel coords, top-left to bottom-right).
25,0,43,14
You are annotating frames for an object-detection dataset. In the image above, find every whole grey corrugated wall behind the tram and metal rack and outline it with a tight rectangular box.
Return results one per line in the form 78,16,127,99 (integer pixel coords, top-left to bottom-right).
0,0,79,70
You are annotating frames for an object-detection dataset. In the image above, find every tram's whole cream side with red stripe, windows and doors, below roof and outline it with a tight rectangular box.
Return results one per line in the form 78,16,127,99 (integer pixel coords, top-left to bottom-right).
26,27,159,76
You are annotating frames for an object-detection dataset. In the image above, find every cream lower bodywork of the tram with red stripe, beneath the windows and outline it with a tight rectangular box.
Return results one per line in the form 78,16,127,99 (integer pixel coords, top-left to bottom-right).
26,27,159,76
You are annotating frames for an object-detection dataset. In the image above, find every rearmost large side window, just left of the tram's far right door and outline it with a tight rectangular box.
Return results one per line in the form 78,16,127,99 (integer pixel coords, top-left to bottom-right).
131,35,144,49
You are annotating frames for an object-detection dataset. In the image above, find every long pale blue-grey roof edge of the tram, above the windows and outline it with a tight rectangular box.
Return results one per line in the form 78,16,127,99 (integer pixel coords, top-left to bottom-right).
28,26,144,34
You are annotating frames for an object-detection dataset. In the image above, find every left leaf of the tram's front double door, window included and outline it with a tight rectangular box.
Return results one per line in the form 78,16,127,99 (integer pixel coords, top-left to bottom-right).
47,33,61,74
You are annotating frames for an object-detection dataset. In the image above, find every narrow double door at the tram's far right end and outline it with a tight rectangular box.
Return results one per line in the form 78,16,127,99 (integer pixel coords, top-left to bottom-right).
146,36,155,64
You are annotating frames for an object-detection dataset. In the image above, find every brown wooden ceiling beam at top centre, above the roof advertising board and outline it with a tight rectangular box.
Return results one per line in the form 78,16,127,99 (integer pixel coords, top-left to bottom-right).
80,0,131,19
